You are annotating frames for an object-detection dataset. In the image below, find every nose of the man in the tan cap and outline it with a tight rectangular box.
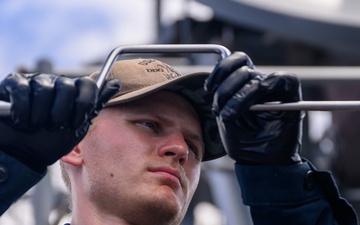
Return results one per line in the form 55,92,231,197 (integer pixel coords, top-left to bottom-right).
158,132,189,164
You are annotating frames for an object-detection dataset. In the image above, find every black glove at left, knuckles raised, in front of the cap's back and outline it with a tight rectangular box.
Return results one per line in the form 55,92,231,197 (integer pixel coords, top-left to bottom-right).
0,74,120,172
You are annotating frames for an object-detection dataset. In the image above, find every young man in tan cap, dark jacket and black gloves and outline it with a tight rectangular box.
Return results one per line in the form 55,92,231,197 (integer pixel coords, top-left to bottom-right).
0,53,357,225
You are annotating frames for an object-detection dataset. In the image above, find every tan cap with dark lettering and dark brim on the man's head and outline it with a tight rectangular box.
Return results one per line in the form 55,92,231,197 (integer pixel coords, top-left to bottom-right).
90,59,226,161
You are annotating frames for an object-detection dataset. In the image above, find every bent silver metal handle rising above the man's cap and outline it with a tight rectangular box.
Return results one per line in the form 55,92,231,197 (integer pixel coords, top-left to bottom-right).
0,44,231,116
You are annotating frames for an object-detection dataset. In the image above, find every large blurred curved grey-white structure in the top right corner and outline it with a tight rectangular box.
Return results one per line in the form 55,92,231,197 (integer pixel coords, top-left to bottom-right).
196,0,360,57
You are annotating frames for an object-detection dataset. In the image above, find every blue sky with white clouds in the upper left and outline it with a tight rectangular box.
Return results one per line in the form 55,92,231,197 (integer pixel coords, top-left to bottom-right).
0,0,155,77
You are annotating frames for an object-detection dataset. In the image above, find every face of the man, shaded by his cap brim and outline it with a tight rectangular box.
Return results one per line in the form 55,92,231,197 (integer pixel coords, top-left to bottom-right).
73,91,204,224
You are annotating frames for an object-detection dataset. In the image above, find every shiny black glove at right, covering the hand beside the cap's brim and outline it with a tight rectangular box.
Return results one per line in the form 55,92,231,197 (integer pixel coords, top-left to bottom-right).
205,52,304,165
